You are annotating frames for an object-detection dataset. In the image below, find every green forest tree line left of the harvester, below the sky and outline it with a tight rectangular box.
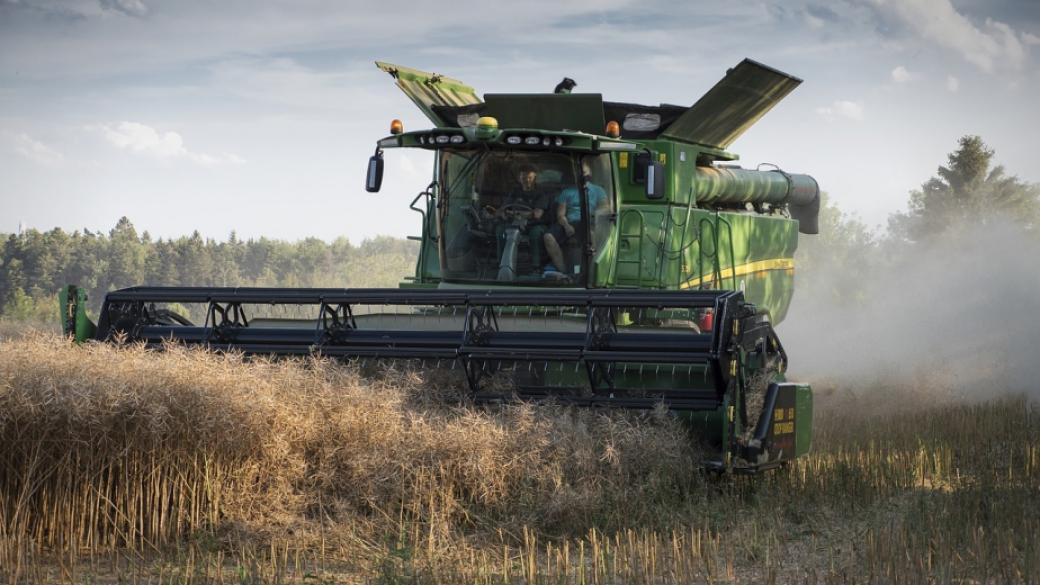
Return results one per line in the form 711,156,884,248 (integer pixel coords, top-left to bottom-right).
0,222,418,323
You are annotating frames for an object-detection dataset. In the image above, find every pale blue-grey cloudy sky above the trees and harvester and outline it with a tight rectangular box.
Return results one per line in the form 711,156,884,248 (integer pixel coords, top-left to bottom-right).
0,0,1040,241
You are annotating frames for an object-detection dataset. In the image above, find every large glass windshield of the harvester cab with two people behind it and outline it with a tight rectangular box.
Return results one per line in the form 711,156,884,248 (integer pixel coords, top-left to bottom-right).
439,151,614,286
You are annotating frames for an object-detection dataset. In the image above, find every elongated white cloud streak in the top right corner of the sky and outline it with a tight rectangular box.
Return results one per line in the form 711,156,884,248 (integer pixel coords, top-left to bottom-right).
869,0,1034,73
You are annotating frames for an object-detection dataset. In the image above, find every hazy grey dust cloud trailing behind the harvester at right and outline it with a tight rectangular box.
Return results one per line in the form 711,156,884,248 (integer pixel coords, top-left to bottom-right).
779,222,1040,400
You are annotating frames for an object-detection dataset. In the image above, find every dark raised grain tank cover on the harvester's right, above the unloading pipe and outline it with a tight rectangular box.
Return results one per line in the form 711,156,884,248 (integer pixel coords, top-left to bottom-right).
661,59,802,150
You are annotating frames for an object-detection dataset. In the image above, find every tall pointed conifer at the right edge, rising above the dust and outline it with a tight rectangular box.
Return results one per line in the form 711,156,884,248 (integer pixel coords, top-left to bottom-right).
889,135,1040,241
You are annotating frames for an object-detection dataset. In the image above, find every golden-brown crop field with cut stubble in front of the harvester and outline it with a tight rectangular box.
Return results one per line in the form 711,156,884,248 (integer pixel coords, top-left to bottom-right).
0,335,1040,584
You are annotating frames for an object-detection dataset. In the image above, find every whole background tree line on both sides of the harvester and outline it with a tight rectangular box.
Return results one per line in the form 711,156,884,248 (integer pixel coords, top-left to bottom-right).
0,135,1040,322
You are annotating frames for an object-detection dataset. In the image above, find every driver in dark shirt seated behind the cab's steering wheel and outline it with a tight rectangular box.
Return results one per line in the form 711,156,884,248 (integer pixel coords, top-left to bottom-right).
495,164,552,273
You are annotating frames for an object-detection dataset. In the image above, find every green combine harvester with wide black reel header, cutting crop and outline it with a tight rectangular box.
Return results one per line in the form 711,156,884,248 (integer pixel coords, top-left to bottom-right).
61,59,820,473
